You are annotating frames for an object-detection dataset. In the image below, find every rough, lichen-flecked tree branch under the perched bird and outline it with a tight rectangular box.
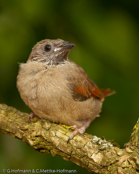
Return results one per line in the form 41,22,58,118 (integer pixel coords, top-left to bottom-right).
0,104,139,174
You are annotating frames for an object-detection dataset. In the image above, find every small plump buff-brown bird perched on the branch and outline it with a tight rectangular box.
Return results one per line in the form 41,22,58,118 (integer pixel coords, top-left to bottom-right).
17,39,114,139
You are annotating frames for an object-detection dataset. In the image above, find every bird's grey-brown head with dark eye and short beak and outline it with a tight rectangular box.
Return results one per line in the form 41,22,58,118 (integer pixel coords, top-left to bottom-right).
28,39,75,65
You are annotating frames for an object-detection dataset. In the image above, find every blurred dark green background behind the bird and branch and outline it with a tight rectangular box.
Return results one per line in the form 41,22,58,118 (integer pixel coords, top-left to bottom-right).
0,0,139,173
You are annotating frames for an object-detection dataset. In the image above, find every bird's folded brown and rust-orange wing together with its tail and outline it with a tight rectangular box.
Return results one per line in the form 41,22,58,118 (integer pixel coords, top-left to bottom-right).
69,65,115,101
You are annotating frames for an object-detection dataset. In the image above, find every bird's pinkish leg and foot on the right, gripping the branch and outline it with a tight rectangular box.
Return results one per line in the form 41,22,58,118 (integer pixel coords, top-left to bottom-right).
68,120,91,141
